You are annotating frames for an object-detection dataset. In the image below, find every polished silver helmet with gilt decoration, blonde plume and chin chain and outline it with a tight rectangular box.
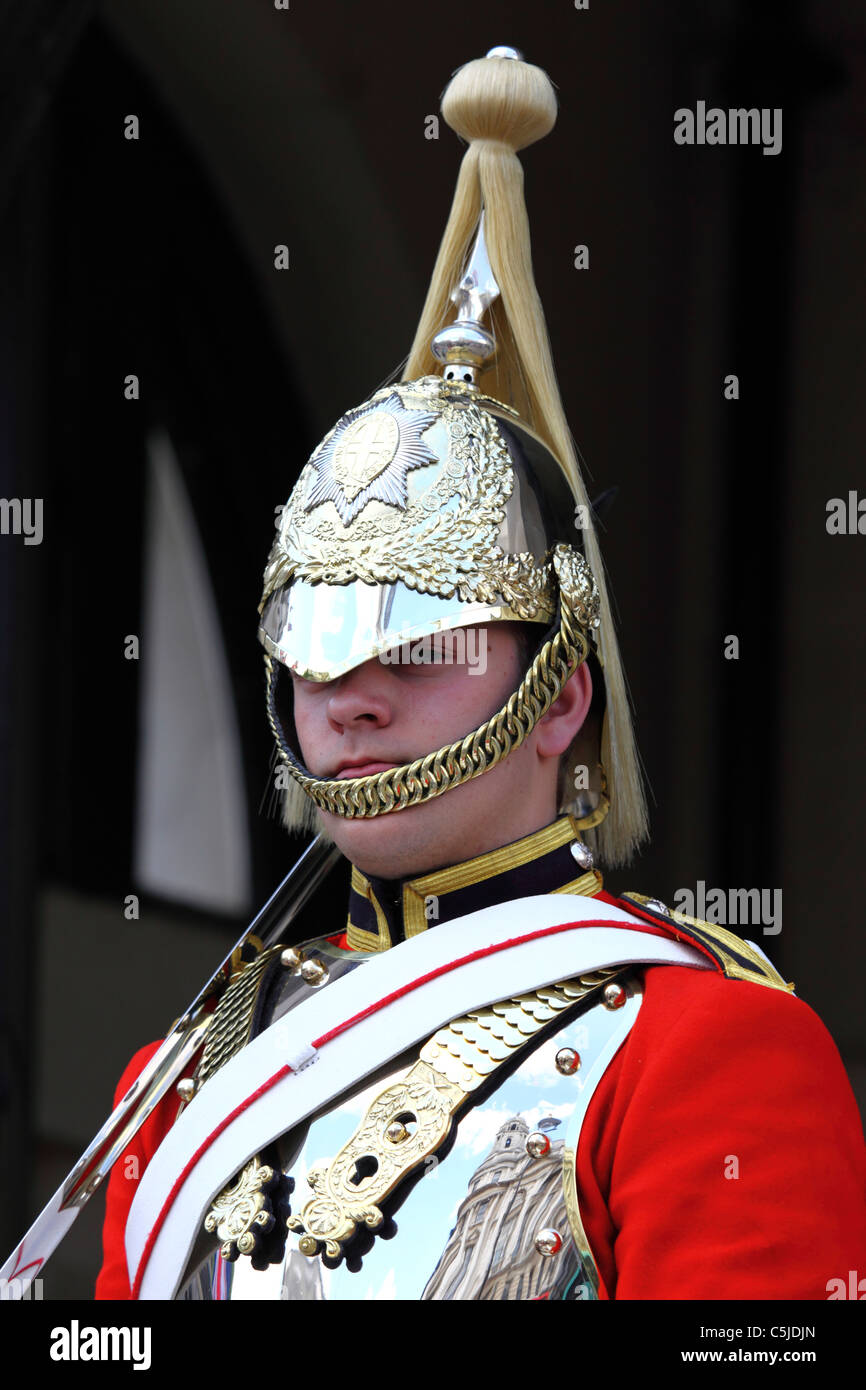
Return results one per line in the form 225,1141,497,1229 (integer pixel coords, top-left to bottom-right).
259,49,646,863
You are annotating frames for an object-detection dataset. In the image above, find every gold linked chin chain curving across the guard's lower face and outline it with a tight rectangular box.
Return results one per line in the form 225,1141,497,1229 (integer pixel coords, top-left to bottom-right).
264,545,599,819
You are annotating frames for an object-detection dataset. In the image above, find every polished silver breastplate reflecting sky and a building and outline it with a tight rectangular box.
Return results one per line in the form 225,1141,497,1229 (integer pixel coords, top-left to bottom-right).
178,948,642,1301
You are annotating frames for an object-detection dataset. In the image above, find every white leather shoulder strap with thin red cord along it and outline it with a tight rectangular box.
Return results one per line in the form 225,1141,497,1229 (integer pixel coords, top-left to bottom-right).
126,894,713,1298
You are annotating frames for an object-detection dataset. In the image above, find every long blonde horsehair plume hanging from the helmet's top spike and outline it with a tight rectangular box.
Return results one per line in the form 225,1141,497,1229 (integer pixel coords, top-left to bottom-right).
403,57,648,865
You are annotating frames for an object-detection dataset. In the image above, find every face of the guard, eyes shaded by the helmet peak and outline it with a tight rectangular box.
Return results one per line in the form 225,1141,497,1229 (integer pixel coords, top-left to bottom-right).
292,623,591,878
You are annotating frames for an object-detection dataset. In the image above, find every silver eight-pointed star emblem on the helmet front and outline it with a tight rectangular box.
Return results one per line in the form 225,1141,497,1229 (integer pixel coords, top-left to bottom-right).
304,392,439,525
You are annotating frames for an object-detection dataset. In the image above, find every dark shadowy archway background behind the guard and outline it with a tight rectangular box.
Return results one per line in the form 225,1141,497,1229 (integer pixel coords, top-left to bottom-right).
0,0,866,1298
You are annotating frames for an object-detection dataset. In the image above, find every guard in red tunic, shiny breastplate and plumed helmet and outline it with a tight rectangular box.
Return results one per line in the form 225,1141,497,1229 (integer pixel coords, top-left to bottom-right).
97,49,863,1300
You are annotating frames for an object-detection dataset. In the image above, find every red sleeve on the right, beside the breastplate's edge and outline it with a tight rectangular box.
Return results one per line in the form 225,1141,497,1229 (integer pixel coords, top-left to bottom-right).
577,966,866,1300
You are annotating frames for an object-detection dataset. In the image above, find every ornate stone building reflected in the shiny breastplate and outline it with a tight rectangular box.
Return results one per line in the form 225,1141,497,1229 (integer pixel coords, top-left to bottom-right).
421,1115,575,1300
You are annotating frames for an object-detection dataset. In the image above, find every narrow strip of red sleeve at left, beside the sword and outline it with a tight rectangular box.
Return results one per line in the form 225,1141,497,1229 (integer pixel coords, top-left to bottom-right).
96,1043,186,1298
